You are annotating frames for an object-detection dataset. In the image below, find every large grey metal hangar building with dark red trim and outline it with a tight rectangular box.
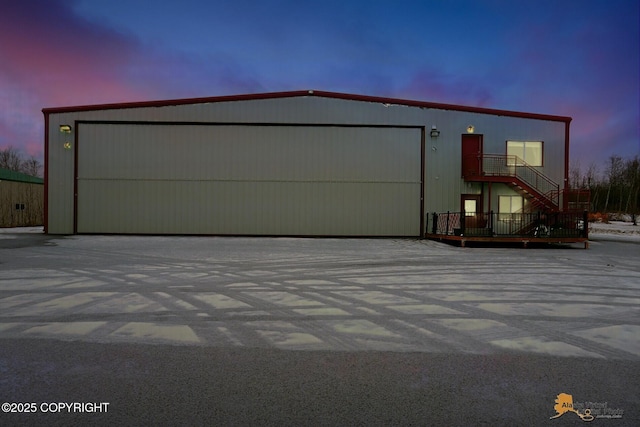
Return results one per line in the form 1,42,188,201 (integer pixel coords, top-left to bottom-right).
43,91,584,241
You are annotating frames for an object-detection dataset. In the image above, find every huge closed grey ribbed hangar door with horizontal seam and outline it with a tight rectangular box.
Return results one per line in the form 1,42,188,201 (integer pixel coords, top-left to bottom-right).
75,123,422,236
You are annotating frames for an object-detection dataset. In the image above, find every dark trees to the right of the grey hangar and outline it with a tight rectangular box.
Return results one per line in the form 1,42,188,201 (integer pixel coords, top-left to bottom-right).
570,155,640,214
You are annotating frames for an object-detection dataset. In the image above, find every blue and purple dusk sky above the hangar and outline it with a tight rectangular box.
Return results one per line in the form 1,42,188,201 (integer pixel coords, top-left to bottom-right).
0,0,640,172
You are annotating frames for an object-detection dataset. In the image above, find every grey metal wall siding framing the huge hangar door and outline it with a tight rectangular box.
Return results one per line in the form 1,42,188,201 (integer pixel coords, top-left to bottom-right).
47,97,566,233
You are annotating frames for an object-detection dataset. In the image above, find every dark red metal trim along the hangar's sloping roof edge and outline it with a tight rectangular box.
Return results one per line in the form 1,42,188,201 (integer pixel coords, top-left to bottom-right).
42,90,571,123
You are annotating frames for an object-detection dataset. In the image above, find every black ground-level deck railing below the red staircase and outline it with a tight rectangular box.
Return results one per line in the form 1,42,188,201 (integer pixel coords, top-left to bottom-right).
426,211,589,238
